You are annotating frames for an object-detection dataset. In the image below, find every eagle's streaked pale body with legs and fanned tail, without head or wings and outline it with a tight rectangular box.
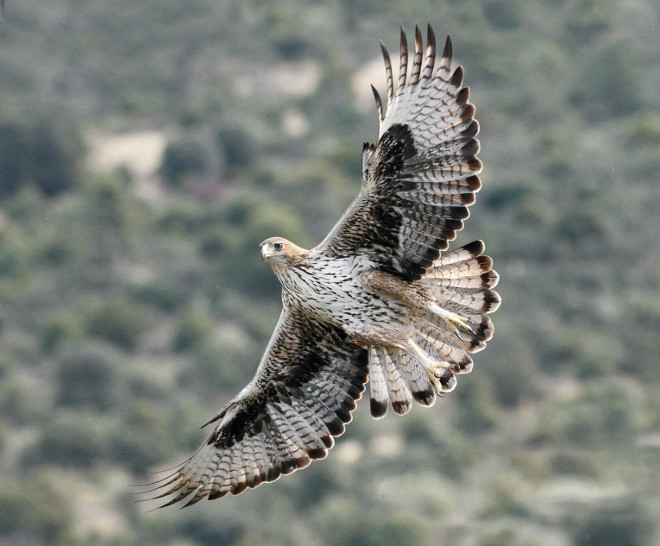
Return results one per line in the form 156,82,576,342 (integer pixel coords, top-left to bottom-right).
274,241,500,417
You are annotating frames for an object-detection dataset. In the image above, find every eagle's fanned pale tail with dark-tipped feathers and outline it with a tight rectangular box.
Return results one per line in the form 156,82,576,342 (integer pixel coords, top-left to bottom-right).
369,241,501,418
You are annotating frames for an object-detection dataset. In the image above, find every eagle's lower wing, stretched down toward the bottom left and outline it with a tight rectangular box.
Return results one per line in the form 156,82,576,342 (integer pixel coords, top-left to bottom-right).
143,309,367,506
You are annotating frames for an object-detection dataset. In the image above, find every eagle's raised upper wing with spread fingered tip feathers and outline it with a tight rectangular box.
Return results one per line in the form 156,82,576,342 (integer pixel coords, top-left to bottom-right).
316,25,481,280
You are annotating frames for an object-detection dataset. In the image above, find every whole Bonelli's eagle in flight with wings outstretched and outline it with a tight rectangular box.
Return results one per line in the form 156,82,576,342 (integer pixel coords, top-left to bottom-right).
146,26,500,506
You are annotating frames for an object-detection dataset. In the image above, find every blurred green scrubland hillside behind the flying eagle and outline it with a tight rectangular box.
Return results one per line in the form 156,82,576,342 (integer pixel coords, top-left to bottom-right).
0,0,660,546
